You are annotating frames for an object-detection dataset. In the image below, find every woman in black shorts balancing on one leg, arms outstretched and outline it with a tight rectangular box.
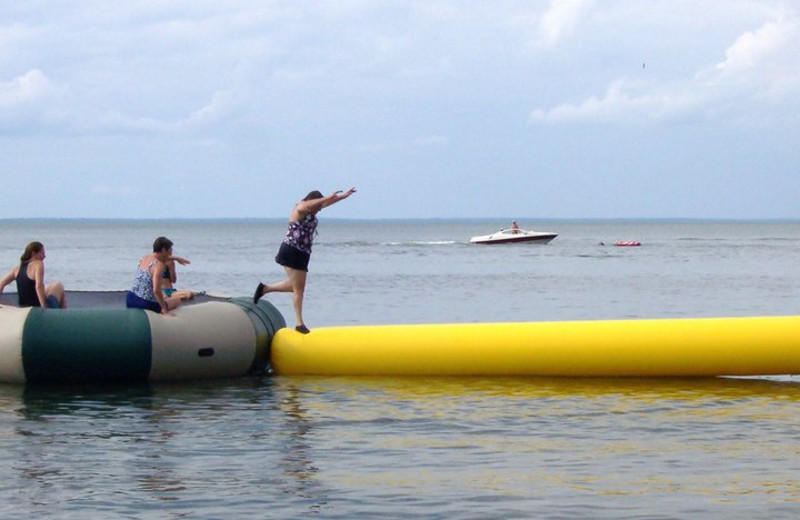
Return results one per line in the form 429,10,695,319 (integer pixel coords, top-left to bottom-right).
253,188,356,334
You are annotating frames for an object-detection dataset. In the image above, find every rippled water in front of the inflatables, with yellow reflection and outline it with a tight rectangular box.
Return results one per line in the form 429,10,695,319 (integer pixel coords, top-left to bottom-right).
0,377,800,518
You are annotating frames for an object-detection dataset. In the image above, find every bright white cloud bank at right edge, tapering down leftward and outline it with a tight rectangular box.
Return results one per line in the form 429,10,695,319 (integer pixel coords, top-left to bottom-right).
530,12,800,123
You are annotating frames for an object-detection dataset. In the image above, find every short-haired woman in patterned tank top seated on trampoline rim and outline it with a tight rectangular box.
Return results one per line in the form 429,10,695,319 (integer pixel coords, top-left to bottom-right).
125,237,181,314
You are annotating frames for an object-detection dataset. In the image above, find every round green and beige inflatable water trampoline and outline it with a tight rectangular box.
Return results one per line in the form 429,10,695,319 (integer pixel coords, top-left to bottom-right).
0,291,286,383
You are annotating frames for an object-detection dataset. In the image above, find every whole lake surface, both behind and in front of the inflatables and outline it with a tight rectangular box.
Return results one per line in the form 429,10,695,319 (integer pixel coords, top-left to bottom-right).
0,216,800,519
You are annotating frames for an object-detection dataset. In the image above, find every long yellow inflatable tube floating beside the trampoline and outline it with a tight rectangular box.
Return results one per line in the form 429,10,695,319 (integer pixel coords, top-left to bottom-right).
271,316,800,377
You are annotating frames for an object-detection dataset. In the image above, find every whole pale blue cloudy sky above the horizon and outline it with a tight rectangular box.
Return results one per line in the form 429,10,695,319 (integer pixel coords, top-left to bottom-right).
0,0,800,219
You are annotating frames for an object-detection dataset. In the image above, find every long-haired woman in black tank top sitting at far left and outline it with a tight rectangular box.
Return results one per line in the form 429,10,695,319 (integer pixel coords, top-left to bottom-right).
0,242,67,309
